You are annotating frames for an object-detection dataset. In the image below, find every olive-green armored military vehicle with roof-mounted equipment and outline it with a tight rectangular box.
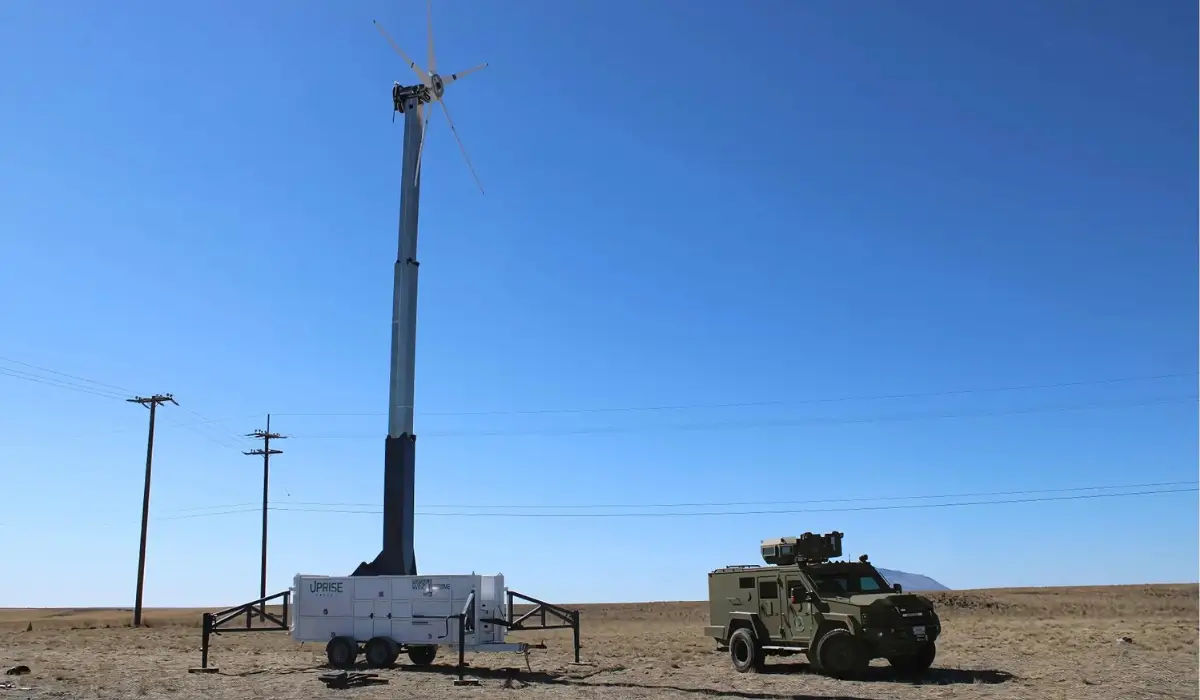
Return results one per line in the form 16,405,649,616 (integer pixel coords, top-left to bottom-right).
704,532,942,678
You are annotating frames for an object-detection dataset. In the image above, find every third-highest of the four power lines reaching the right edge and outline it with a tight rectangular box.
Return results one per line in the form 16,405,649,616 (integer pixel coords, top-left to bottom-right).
150,479,1200,516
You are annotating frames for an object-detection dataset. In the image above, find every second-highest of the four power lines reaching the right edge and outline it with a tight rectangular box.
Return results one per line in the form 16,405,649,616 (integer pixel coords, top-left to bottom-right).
285,396,1198,439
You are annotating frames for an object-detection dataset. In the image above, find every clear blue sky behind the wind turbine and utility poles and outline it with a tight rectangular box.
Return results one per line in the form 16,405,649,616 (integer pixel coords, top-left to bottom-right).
0,0,1200,605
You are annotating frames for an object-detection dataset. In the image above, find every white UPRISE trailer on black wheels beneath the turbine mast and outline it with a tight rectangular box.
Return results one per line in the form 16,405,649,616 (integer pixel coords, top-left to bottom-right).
289,574,529,668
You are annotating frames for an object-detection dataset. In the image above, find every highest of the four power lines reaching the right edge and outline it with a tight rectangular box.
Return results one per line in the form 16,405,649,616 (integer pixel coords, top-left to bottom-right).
275,372,1198,417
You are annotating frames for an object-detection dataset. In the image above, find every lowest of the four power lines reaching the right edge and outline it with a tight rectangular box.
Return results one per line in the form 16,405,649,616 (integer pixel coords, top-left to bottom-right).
154,486,1200,520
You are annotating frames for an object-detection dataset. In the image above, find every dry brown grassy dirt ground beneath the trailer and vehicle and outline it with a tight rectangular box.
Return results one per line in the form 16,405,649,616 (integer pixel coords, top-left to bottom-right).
0,585,1200,700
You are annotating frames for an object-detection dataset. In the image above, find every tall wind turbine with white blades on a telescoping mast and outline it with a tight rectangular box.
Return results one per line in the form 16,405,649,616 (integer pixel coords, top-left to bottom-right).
352,0,487,576
